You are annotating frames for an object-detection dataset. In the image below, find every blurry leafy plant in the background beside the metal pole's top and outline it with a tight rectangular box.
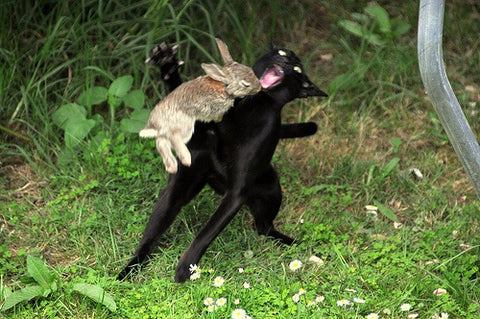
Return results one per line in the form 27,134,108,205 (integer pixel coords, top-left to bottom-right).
339,3,410,46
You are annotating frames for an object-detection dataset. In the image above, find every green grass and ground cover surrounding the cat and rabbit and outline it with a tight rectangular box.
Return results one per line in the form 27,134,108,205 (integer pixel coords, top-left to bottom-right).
0,0,480,318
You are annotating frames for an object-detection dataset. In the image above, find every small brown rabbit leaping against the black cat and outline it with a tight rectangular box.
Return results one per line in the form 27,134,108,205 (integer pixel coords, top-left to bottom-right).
139,39,261,174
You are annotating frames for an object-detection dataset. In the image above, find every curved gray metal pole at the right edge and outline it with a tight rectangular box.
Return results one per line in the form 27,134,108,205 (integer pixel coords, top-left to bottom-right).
418,0,480,198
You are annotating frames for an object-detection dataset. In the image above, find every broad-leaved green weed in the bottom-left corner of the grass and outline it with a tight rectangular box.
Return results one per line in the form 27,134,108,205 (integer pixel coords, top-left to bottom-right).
0,255,117,312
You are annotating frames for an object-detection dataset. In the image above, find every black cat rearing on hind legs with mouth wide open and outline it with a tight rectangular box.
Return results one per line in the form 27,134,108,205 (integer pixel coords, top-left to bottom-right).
118,45,326,282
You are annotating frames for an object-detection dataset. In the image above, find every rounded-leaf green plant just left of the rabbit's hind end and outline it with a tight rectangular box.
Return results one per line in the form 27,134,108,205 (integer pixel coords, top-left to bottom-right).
53,75,150,148
